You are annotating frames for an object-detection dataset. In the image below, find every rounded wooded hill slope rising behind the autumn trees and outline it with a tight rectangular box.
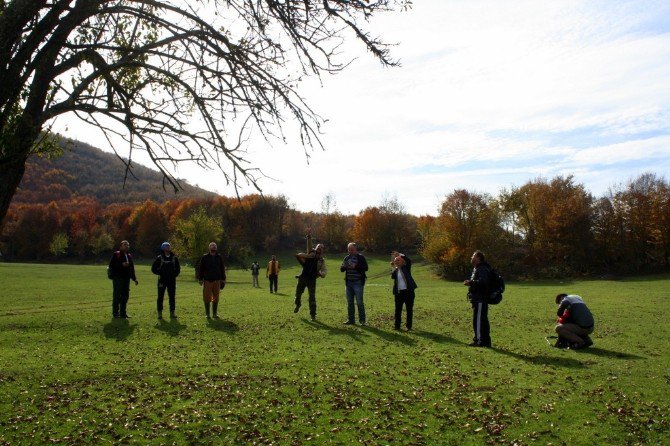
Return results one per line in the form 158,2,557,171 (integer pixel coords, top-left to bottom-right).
12,139,216,206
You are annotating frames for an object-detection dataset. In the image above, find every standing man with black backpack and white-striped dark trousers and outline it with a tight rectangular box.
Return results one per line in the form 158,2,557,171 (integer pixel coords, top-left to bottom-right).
463,251,492,347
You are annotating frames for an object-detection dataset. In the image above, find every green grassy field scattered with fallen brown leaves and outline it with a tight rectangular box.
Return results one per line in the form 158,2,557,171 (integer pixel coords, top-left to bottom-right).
0,256,670,445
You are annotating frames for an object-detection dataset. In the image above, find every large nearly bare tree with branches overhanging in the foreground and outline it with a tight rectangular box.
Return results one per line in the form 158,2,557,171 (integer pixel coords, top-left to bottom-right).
0,0,410,233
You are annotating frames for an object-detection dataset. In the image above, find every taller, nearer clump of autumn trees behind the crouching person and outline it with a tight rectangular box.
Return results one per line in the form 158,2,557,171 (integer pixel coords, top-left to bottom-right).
420,173,670,278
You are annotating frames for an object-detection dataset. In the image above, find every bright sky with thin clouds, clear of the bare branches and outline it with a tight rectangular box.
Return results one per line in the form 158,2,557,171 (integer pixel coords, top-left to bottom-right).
52,0,670,215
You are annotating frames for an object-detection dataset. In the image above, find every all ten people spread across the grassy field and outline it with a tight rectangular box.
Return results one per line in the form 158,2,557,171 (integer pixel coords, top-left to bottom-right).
108,239,594,349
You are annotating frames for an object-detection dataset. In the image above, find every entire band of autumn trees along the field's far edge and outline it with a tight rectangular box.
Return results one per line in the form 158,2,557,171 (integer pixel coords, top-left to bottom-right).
0,173,670,278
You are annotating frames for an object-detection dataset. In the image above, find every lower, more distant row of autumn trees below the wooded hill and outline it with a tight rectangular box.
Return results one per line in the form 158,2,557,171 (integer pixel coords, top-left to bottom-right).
0,194,418,267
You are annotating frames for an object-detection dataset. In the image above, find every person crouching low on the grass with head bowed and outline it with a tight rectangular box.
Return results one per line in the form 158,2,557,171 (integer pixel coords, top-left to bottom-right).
556,293,595,350
